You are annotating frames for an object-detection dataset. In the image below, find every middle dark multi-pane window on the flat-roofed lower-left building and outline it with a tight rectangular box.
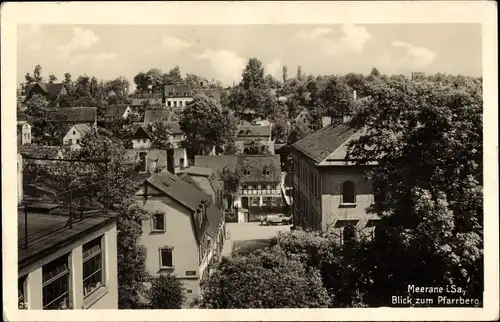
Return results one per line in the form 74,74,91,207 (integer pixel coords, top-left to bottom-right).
42,255,69,310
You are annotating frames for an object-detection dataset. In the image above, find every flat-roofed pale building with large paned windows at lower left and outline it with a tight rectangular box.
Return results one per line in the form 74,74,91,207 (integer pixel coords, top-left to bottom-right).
18,204,118,310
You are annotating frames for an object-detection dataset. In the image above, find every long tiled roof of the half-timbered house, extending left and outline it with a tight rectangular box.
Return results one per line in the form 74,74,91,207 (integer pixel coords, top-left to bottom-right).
194,154,281,182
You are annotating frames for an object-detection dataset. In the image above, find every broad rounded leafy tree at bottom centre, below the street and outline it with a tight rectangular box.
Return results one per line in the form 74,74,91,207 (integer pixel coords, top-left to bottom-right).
197,247,330,309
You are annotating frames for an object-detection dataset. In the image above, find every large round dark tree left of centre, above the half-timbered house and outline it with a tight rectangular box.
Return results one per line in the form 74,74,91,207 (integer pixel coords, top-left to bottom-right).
179,96,236,155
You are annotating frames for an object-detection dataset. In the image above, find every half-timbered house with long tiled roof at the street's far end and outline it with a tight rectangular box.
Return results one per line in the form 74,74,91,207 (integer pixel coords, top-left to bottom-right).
194,155,283,222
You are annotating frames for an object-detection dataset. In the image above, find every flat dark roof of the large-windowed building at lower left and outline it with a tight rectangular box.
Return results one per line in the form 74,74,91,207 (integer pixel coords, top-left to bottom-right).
17,204,115,268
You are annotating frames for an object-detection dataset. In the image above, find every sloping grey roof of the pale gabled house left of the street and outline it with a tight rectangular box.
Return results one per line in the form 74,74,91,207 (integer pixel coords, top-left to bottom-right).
146,171,207,211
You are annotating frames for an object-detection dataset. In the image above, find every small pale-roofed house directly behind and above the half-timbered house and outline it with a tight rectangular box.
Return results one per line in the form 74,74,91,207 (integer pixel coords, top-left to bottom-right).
235,125,274,154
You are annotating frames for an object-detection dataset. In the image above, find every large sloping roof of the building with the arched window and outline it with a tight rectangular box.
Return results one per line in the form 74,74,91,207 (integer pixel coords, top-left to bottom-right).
292,123,357,163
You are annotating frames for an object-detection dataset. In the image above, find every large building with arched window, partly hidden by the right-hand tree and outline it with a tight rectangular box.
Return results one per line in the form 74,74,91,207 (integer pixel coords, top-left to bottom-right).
292,118,378,239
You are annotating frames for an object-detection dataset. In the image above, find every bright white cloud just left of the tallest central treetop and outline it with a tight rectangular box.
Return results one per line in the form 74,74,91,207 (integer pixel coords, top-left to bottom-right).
192,49,246,85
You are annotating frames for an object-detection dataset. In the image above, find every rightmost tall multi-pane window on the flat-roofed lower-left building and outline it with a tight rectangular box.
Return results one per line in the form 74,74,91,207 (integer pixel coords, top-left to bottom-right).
82,237,103,297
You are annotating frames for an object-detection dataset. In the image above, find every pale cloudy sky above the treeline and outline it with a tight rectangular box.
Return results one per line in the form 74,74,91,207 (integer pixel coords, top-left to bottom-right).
17,24,482,85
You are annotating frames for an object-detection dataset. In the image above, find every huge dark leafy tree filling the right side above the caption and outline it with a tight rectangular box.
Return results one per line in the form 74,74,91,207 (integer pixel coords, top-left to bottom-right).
348,78,483,306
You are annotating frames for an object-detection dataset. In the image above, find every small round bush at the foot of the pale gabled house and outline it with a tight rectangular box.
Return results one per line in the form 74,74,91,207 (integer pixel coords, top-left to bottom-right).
146,273,186,310
